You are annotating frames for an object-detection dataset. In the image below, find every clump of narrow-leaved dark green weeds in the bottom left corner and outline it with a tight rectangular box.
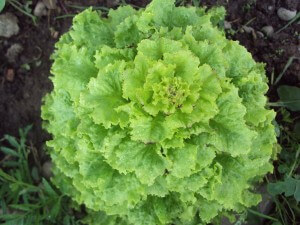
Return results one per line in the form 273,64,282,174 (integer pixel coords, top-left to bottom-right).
0,126,81,225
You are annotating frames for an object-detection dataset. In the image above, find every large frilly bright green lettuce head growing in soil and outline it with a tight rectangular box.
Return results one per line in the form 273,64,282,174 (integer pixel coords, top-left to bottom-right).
42,0,276,225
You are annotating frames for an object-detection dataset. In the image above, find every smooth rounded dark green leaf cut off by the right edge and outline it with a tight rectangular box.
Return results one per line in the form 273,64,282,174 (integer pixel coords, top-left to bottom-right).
277,85,300,111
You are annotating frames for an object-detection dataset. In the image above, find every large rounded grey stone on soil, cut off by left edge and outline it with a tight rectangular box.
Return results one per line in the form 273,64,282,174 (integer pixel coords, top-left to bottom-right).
0,13,20,38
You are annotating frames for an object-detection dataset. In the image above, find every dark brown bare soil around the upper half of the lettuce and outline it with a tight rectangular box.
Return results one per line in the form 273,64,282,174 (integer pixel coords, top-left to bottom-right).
0,0,300,160
